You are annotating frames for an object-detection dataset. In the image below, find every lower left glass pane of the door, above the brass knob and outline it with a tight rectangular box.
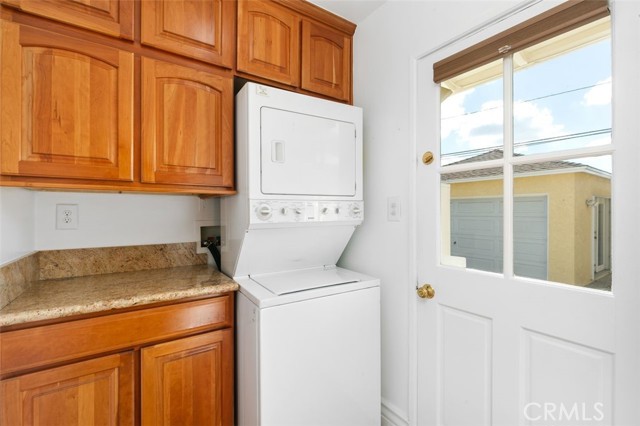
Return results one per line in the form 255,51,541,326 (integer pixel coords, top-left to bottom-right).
440,172,503,273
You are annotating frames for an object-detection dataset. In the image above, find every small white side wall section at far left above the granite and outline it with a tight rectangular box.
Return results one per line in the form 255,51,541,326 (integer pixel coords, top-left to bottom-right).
0,188,36,266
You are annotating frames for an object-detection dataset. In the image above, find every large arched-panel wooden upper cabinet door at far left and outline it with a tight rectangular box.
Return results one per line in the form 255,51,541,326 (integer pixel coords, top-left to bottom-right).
0,21,133,181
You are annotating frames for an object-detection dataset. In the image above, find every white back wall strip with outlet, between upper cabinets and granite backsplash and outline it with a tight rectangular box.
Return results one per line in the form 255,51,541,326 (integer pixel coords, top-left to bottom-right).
34,191,220,250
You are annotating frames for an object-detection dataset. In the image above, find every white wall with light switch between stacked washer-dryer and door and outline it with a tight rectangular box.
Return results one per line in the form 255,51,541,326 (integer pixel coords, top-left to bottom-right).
340,0,518,425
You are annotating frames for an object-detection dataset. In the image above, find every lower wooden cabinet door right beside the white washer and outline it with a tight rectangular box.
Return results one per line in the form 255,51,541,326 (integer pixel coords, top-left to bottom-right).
141,329,233,426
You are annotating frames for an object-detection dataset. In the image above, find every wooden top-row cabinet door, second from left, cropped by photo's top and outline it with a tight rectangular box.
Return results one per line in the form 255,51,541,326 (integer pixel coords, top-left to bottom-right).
141,0,236,68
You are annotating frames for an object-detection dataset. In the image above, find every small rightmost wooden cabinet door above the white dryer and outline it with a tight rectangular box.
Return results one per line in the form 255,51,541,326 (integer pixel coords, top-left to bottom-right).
301,20,351,101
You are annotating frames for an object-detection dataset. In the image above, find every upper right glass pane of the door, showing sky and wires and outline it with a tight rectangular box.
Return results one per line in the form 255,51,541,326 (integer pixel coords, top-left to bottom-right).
513,18,611,155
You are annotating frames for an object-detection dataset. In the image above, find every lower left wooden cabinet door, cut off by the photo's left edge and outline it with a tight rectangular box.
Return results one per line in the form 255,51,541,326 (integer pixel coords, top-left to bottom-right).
0,352,134,426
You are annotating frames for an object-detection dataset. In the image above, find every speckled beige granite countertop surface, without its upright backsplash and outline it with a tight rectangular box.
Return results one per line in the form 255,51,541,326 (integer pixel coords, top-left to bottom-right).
0,265,238,326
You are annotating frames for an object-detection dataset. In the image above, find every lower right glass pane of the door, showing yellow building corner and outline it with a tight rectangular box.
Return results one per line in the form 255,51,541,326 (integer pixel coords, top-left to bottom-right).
513,156,612,291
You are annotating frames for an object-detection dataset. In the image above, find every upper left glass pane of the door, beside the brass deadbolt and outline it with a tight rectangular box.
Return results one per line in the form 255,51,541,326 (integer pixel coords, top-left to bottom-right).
440,60,504,165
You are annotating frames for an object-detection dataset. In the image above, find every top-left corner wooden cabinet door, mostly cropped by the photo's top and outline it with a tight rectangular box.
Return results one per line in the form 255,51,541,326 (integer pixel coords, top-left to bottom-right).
2,0,133,40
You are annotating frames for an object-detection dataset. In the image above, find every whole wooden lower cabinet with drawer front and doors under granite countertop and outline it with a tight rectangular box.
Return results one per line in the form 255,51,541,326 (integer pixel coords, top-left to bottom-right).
0,293,234,426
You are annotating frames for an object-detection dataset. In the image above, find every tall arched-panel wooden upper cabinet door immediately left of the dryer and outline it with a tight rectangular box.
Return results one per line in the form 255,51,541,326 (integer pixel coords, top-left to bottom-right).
142,58,234,187
